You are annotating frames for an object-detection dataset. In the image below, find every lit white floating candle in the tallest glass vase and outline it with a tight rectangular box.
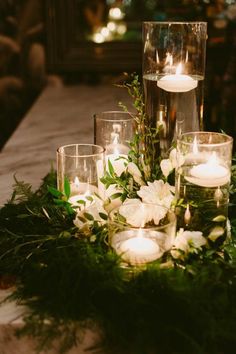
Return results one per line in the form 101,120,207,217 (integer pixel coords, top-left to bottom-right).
157,63,198,92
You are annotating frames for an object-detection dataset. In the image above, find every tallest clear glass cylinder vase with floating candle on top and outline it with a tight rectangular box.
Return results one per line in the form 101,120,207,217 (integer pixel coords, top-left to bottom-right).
143,22,207,156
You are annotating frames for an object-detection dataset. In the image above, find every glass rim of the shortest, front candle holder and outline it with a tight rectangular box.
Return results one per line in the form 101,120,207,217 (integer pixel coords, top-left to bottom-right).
108,202,177,231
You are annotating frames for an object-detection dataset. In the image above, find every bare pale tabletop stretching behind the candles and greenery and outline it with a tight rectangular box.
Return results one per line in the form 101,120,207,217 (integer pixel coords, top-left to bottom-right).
0,84,131,205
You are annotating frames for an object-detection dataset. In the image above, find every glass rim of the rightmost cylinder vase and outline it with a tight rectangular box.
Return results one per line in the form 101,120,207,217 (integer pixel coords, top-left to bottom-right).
177,131,233,147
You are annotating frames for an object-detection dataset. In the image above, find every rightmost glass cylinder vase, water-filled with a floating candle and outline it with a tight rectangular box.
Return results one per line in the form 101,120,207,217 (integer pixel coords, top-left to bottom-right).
176,132,233,245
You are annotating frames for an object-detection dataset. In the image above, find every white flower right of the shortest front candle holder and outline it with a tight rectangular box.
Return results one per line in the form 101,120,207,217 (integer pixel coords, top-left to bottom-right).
171,229,206,258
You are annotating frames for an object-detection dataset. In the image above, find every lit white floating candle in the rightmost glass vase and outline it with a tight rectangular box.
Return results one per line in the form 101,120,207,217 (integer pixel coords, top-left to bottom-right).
185,155,230,187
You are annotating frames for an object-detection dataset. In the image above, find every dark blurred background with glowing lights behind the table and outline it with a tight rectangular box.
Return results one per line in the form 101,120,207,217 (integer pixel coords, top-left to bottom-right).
0,0,236,148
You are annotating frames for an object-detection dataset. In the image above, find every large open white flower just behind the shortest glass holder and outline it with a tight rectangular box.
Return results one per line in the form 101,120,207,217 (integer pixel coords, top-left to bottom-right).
137,180,174,209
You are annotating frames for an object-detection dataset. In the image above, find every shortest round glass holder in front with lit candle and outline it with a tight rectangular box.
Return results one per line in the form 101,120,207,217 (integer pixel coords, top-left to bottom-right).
108,203,176,267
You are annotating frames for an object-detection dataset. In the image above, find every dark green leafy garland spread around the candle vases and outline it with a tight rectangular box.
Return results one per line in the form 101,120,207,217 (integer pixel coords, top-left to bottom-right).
0,78,236,354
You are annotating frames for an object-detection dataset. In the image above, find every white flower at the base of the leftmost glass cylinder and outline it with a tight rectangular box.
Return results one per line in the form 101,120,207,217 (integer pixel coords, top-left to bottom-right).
74,198,107,228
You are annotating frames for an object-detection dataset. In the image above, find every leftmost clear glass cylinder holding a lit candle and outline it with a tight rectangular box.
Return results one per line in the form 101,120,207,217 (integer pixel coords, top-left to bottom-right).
57,144,105,207
